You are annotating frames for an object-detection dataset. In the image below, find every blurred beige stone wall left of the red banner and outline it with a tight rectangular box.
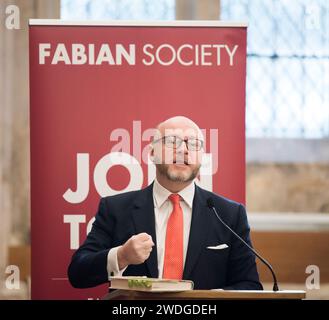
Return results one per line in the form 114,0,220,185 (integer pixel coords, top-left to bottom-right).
0,0,60,289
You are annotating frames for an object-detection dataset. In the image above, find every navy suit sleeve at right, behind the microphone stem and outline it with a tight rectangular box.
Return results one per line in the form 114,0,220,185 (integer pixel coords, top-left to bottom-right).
224,205,263,290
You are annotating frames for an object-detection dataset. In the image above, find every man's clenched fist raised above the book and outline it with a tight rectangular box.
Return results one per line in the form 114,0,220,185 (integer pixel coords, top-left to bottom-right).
118,232,154,270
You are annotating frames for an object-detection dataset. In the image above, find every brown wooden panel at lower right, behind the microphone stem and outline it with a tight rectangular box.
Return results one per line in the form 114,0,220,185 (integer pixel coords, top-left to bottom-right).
252,231,329,283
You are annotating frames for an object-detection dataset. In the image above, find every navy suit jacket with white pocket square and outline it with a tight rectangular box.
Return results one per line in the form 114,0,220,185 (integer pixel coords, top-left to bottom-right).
68,184,262,290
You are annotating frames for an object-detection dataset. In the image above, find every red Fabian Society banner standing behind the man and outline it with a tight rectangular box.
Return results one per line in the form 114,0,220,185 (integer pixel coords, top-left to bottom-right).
29,20,246,299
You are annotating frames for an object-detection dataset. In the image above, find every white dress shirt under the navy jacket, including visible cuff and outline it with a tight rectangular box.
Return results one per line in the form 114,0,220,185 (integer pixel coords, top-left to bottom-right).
107,179,195,278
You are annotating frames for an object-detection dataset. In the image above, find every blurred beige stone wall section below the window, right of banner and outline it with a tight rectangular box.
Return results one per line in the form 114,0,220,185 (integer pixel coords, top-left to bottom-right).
246,163,329,213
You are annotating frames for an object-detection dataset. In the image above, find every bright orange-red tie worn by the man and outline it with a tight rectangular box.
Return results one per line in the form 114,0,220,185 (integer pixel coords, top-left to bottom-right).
163,194,183,279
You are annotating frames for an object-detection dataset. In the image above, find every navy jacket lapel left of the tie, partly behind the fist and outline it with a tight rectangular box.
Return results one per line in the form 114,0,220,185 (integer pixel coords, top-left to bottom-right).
132,183,158,278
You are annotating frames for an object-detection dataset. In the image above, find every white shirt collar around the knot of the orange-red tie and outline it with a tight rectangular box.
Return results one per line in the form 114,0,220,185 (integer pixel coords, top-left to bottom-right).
153,178,195,209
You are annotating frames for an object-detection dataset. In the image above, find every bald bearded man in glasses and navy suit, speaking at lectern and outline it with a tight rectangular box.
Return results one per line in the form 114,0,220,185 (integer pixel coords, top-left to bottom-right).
68,116,262,290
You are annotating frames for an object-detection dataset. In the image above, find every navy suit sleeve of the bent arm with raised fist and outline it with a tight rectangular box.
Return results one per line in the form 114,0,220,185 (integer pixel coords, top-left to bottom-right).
68,199,116,288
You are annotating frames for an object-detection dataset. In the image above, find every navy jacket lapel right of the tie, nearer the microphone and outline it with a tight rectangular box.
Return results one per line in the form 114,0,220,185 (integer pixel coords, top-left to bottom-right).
183,186,209,279
